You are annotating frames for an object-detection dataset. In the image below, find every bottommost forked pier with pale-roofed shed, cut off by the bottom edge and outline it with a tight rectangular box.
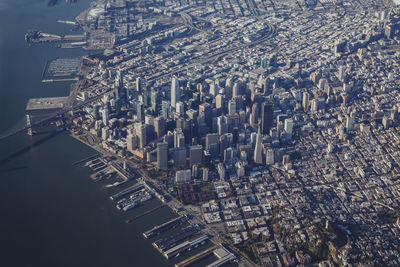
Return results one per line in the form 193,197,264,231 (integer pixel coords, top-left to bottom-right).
175,245,236,267
